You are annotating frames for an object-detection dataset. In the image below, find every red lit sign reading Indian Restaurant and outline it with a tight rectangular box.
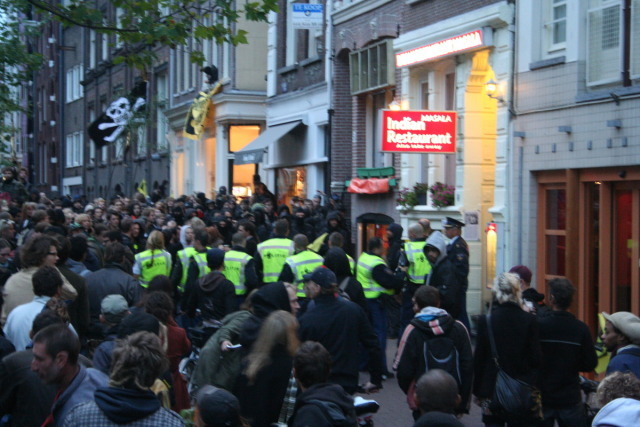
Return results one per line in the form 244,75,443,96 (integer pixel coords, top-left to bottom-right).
382,110,458,153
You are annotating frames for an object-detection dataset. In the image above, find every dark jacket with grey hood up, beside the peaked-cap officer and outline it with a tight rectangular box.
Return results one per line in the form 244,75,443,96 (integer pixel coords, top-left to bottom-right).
424,231,464,318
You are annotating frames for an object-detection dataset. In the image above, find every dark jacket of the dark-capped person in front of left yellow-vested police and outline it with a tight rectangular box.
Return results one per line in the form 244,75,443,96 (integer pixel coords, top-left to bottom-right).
187,270,236,321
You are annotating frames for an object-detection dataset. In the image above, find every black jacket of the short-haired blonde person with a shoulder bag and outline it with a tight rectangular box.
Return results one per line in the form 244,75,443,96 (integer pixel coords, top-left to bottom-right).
473,302,542,398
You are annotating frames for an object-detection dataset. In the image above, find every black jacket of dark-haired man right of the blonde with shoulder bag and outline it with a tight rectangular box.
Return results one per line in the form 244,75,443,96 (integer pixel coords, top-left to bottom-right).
538,311,598,408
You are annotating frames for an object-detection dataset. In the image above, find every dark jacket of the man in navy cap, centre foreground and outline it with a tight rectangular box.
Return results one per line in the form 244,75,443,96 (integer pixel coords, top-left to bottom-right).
300,294,382,393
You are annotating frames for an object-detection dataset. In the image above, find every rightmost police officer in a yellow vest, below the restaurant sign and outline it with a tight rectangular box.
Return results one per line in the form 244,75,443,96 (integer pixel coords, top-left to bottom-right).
398,223,431,337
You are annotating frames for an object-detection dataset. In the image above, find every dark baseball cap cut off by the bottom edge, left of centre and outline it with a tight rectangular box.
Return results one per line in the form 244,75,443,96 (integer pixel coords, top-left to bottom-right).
196,385,241,427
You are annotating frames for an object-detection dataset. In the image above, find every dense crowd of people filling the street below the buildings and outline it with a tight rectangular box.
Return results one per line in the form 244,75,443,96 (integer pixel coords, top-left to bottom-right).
0,165,640,427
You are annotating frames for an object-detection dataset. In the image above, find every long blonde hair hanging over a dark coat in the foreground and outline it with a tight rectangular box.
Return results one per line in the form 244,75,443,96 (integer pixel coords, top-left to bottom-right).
244,310,300,384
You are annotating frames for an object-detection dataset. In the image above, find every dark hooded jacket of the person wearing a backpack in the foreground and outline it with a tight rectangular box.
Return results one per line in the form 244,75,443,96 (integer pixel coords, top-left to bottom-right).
396,307,473,413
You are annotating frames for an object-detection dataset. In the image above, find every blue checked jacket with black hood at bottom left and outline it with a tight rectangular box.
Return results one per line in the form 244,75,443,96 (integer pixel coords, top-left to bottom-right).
64,387,184,427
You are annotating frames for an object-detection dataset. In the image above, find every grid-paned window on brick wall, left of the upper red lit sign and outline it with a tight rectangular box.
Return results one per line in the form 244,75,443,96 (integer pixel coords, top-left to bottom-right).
349,41,395,95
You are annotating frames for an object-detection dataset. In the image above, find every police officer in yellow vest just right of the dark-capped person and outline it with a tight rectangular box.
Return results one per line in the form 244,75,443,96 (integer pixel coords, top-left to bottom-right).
222,232,258,306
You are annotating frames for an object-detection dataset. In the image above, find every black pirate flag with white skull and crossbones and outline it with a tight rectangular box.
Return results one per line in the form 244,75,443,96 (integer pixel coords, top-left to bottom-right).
87,81,147,148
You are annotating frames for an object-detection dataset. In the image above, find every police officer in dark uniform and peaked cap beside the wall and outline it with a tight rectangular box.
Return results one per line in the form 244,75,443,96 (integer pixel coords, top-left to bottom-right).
442,217,470,329
